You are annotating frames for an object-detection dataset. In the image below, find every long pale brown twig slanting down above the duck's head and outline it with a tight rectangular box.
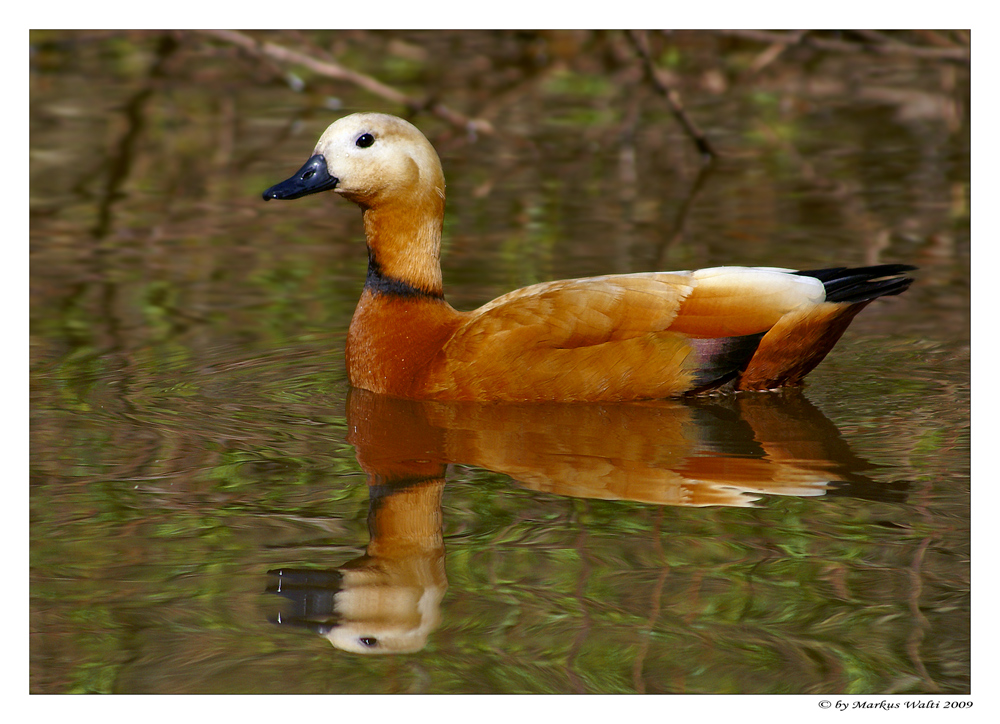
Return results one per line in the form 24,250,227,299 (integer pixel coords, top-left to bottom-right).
196,30,494,135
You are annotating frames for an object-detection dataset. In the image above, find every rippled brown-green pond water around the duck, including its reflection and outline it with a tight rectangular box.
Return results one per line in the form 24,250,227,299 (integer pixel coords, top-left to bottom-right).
30,33,971,694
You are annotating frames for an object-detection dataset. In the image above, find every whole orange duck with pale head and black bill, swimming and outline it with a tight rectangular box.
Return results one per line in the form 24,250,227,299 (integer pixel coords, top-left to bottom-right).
264,113,913,402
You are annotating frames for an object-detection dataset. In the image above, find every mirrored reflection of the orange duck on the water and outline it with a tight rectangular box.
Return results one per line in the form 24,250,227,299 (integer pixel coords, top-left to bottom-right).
268,390,906,653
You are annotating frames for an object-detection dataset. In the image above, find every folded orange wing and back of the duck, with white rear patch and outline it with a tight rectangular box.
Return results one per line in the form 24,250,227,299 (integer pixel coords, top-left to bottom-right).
424,267,844,401
